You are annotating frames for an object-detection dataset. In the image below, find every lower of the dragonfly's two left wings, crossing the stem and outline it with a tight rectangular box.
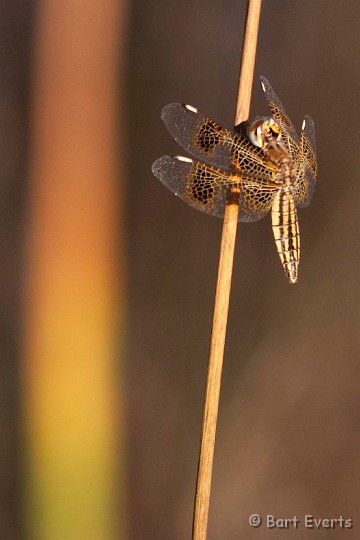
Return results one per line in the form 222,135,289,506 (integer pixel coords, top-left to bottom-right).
152,156,279,222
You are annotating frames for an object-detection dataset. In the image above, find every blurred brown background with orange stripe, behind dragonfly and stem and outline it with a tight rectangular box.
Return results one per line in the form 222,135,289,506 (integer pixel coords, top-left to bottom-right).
0,0,360,540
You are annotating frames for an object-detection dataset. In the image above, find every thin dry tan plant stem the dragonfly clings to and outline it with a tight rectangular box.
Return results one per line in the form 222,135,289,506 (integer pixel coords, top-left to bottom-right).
192,0,261,540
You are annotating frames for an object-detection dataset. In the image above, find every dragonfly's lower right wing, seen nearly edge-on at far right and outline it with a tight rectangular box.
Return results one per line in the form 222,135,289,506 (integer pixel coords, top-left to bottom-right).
294,116,317,207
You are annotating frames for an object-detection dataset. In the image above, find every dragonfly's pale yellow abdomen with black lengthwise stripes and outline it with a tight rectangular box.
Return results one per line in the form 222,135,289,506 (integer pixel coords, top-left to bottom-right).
271,186,300,283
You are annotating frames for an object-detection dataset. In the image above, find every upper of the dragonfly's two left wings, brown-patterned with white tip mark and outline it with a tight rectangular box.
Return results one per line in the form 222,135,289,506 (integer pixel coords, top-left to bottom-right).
161,103,277,180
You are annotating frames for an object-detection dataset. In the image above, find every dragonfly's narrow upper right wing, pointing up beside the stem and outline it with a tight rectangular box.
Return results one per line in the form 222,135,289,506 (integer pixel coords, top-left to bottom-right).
260,76,300,157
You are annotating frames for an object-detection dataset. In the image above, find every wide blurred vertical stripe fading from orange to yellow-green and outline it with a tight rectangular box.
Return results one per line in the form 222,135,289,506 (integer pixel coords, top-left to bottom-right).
23,0,125,540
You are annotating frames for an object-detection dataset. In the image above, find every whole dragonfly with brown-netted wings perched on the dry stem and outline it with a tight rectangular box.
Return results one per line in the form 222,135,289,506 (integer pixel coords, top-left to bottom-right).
152,76,317,283
